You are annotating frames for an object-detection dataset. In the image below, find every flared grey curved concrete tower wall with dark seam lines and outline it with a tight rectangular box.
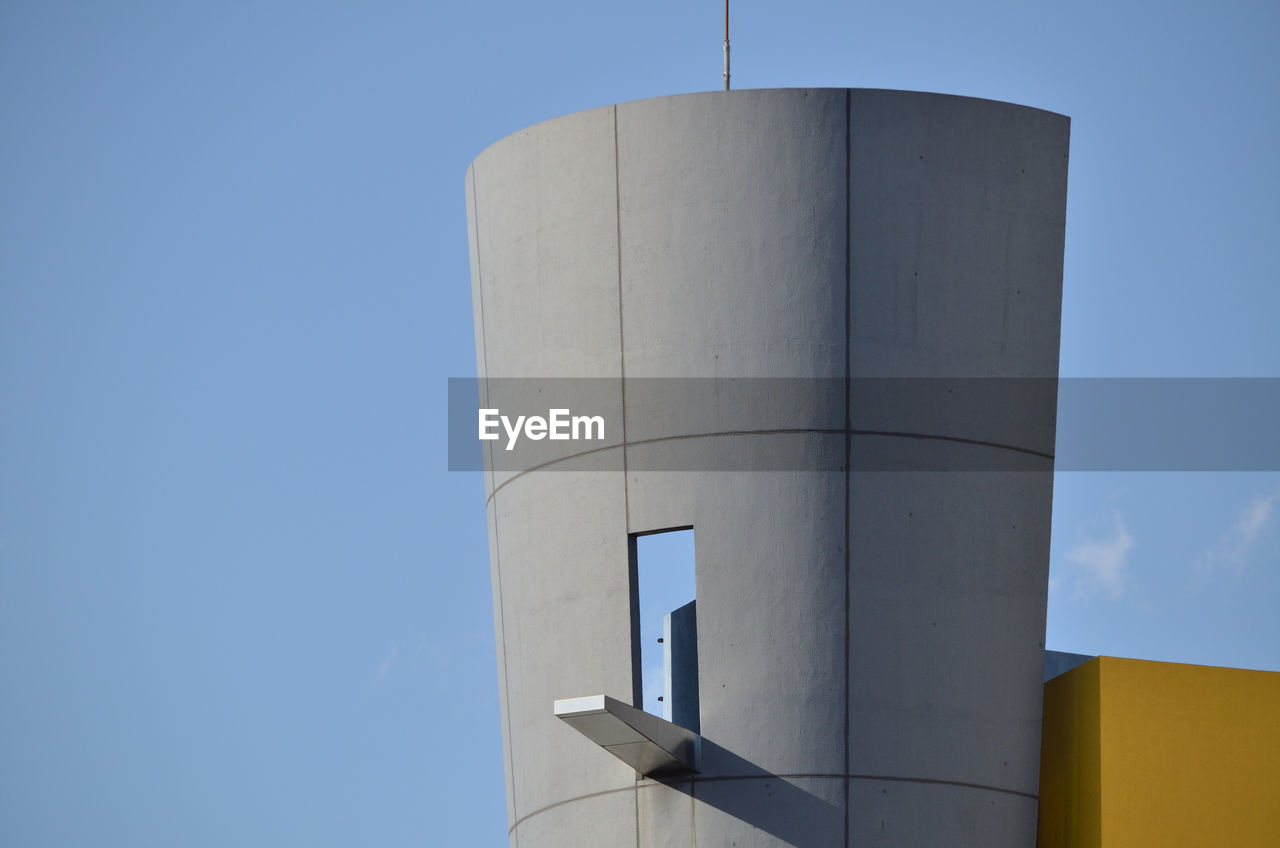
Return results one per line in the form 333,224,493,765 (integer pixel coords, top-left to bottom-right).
466,90,1069,848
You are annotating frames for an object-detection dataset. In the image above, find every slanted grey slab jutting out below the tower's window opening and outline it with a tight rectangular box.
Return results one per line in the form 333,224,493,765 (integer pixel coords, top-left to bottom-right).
556,694,701,776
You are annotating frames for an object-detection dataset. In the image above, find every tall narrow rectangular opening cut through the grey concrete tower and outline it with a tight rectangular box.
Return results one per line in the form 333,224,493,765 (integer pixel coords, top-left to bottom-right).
630,526,700,731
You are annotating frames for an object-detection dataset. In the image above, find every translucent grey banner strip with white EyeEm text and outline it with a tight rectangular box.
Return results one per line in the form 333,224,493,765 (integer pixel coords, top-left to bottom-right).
448,378,1280,473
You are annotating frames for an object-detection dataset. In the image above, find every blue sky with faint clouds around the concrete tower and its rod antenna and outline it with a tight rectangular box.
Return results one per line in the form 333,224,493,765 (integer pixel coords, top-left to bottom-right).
0,0,1280,848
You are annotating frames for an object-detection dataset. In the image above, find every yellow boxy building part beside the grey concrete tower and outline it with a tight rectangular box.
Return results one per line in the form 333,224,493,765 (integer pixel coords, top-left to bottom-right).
1039,657,1280,848
